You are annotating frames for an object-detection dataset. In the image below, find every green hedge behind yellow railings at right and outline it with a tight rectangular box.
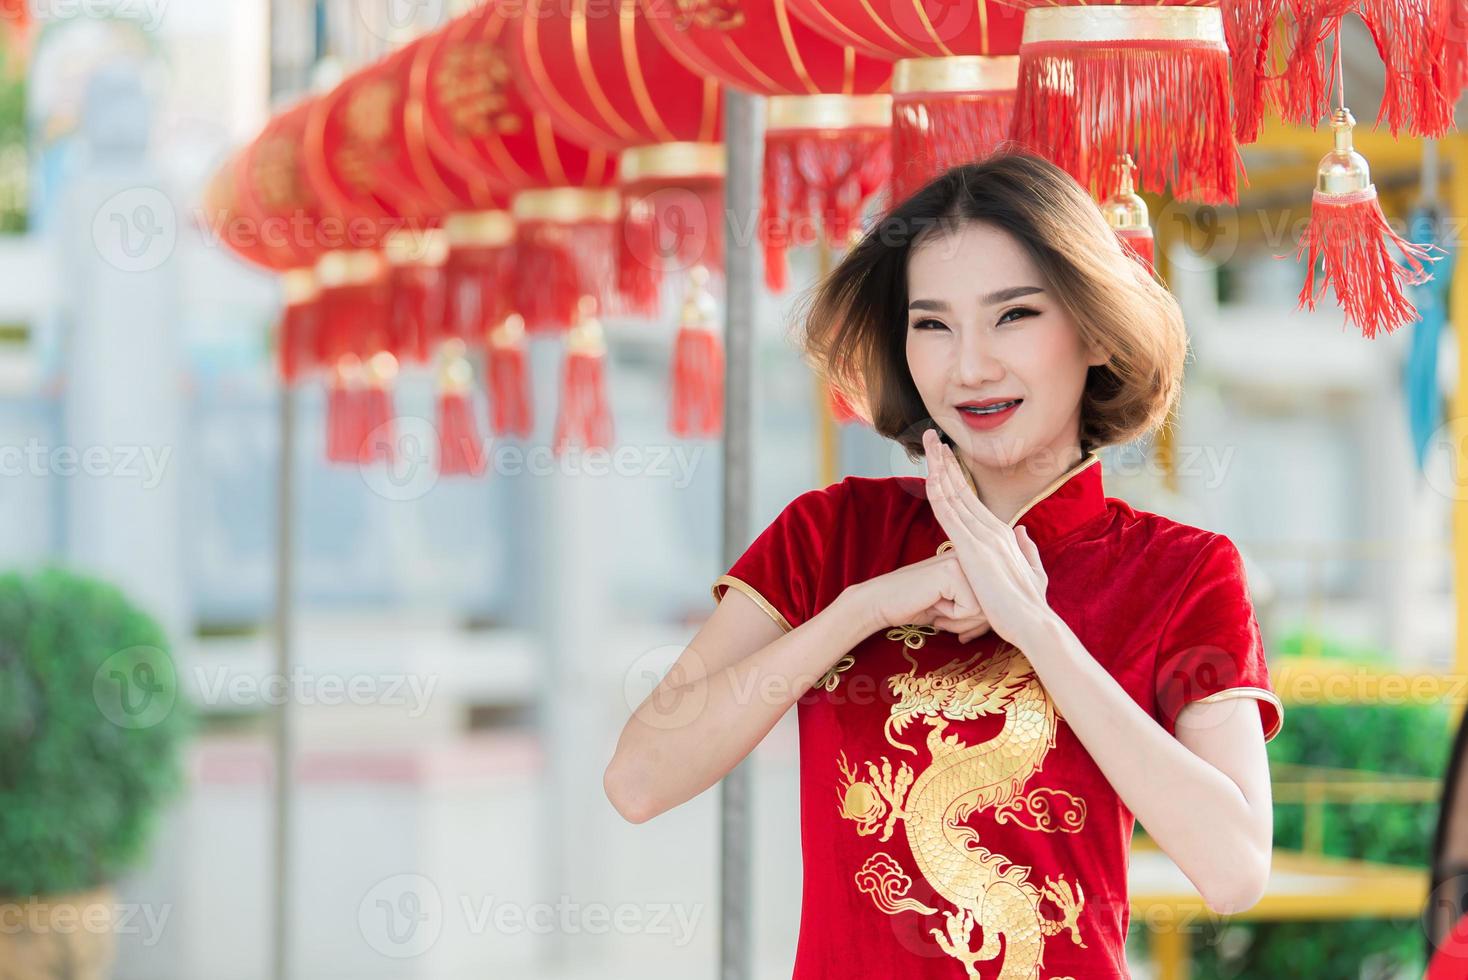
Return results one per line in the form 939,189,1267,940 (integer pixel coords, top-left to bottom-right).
1162,632,1452,980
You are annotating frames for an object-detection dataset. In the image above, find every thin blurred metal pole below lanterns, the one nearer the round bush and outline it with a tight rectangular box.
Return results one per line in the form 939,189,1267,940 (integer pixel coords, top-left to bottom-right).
270,377,295,980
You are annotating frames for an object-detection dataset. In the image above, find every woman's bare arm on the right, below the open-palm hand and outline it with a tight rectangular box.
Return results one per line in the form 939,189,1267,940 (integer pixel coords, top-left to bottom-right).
1016,610,1274,915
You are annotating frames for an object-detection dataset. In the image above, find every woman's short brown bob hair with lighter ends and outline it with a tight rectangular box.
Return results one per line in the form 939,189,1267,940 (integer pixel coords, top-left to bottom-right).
797,150,1188,461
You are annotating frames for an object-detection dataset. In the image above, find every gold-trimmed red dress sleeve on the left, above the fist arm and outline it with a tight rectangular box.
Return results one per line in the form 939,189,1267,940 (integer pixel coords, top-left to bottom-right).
712,483,844,632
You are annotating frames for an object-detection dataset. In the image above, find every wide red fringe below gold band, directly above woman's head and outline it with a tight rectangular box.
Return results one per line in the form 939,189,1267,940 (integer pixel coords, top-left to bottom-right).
1013,41,1242,204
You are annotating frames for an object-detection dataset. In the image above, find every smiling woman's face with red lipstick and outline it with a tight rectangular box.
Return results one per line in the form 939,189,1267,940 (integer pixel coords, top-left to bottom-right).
907,222,1105,469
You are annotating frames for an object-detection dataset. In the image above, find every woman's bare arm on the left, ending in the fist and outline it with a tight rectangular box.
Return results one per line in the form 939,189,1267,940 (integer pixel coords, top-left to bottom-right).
602,585,879,823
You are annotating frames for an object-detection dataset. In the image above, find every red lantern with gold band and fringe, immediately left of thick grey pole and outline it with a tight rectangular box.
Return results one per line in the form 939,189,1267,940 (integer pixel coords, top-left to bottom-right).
514,0,724,312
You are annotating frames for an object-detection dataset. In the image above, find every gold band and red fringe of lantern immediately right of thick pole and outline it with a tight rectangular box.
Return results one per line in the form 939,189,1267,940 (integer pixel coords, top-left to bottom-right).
759,94,893,292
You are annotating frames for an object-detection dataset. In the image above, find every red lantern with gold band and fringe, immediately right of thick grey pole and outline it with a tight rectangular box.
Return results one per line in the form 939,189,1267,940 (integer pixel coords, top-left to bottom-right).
642,0,893,292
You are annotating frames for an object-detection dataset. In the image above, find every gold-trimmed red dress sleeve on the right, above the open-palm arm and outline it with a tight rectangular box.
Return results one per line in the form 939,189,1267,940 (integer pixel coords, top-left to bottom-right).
1155,534,1285,741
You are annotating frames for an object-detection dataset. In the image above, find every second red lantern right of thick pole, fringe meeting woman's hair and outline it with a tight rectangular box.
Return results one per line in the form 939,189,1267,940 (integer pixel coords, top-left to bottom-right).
790,0,1023,202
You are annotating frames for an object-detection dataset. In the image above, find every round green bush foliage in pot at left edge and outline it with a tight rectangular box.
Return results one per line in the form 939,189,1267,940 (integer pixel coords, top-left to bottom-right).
0,569,194,896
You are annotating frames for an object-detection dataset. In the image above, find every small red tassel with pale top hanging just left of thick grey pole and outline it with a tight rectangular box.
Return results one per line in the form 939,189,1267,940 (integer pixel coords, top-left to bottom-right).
668,267,724,439
